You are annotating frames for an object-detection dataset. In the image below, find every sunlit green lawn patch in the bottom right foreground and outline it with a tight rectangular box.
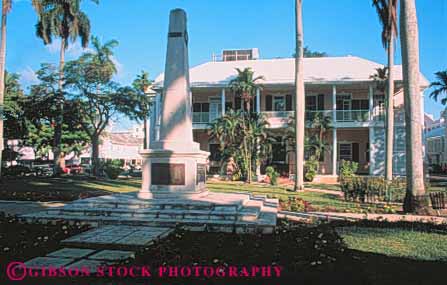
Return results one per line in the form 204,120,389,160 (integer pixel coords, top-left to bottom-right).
337,227,447,261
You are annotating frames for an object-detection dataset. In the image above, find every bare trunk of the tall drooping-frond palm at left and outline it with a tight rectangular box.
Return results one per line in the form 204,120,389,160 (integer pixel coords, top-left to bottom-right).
53,38,66,176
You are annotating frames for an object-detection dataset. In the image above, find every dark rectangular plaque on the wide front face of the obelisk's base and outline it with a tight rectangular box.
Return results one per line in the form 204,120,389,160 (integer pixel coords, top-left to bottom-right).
151,163,185,185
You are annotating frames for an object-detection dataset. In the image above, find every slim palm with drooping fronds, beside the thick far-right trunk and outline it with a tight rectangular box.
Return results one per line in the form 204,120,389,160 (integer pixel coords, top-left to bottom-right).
373,0,397,181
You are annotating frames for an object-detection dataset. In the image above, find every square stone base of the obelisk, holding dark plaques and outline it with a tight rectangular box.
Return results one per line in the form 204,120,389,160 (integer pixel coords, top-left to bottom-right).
138,149,209,199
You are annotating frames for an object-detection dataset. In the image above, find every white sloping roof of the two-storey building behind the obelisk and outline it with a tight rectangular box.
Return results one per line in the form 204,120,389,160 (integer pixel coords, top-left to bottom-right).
155,56,429,87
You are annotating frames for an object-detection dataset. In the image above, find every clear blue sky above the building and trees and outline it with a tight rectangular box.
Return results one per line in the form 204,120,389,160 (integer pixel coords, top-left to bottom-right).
7,0,447,127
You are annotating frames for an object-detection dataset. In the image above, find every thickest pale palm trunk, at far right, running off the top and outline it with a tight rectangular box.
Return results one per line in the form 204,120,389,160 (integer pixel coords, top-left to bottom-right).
400,0,432,214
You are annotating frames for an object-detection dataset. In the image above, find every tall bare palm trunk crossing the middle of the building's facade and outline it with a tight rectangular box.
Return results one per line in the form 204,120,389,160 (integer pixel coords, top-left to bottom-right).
295,0,305,191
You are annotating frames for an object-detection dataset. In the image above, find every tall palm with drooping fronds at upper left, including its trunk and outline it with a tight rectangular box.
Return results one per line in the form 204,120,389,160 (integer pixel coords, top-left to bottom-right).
33,0,98,175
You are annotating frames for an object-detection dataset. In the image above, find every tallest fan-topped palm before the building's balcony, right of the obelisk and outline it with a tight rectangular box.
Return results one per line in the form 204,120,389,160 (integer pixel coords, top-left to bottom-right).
229,68,264,183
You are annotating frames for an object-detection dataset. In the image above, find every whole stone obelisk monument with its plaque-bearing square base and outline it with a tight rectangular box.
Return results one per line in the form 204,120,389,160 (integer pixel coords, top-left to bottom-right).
138,9,209,199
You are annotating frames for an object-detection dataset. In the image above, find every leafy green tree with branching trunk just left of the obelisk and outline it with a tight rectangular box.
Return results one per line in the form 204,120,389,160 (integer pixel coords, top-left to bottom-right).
65,38,150,176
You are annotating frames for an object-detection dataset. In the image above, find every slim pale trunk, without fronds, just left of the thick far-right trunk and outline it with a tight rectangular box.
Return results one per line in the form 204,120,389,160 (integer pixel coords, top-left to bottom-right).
385,4,394,181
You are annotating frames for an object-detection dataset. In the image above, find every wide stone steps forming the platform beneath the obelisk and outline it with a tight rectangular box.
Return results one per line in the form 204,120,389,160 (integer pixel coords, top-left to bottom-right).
23,193,278,233
